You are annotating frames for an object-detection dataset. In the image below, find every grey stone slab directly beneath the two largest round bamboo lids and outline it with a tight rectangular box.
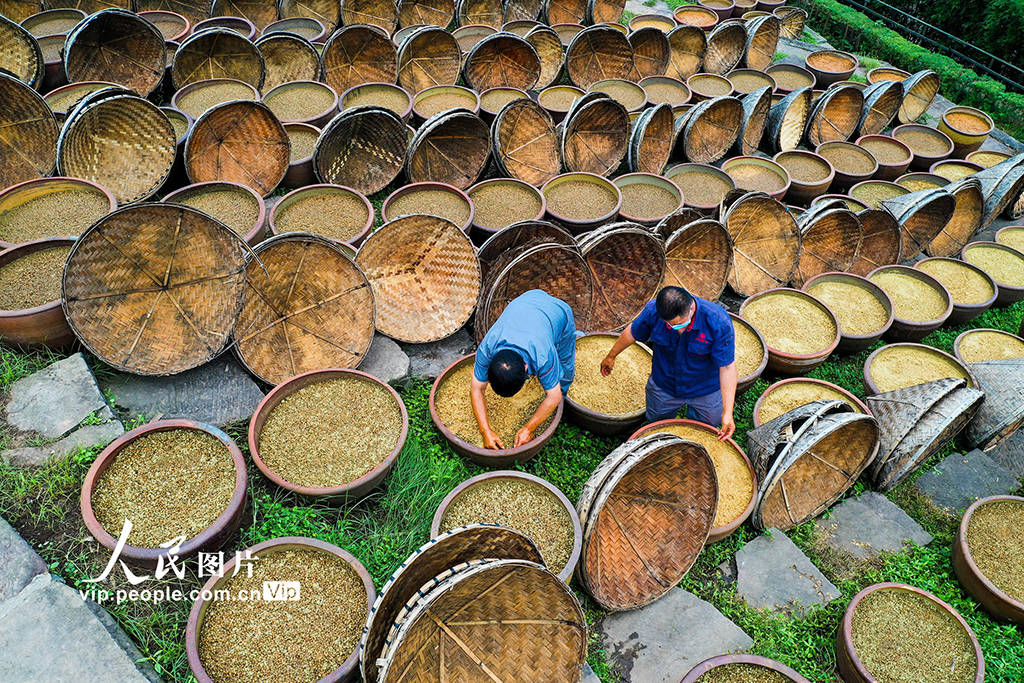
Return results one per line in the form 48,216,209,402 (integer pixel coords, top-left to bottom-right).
102,354,263,427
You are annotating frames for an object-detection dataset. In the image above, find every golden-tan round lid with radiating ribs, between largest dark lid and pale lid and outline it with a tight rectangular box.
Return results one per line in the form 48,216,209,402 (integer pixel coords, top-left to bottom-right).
234,232,374,384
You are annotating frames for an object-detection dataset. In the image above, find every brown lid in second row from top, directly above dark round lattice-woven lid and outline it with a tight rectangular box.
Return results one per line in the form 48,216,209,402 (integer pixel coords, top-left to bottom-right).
323,26,398,92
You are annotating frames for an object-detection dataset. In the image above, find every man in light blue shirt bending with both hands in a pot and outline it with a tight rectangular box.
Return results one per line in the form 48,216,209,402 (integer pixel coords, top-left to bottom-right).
470,290,577,449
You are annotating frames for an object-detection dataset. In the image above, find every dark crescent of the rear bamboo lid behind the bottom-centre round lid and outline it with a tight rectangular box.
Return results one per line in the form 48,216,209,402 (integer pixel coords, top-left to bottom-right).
359,524,544,683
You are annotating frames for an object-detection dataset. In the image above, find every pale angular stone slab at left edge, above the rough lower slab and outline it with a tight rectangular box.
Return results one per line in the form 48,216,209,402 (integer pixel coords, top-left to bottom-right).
5,353,106,438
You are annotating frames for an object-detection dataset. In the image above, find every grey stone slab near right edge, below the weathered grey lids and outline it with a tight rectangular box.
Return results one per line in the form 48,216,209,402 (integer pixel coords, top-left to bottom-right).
913,449,1018,512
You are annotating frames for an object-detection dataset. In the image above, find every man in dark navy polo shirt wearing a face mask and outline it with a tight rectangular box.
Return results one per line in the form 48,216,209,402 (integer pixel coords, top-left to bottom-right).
601,287,737,439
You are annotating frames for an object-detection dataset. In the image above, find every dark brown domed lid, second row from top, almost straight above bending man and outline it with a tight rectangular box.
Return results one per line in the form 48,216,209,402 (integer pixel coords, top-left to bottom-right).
463,33,544,92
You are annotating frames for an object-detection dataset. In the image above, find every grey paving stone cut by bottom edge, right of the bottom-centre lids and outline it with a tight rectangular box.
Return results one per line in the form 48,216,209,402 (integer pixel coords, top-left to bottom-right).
601,588,754,683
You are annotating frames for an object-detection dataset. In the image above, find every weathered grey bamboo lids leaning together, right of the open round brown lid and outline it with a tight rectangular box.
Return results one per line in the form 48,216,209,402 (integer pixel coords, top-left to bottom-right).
867,378,985,493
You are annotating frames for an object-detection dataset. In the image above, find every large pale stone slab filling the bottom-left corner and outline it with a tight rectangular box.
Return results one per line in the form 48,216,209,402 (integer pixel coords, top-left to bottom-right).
0,573,160,683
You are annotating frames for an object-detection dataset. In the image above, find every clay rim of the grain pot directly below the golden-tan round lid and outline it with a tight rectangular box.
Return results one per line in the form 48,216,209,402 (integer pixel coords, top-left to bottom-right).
248,368,409,497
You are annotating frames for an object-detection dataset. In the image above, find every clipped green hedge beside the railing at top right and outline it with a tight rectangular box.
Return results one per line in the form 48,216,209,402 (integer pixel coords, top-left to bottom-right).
794,0,1024,140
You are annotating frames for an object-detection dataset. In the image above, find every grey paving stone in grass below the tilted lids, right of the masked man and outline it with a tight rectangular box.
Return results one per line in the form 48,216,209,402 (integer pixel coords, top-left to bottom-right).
814,492,932,560
